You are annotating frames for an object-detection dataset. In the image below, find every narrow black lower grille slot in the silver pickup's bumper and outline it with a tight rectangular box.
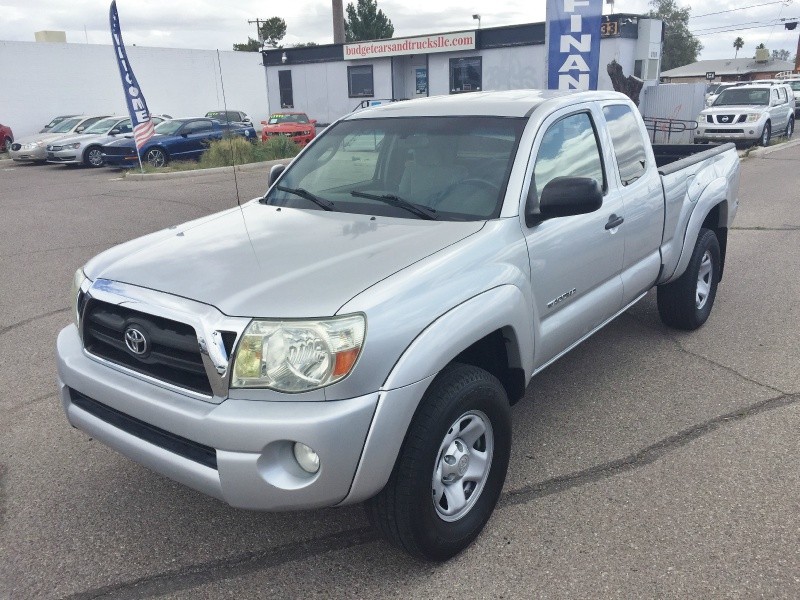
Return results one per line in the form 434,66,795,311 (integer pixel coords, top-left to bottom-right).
69,388,217,469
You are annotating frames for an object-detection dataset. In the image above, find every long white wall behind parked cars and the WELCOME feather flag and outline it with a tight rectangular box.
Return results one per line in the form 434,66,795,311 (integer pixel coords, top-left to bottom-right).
0,41,269,138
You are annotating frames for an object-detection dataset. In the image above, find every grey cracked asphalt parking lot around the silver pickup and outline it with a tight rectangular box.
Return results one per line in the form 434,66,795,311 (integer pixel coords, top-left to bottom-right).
0,151,800,600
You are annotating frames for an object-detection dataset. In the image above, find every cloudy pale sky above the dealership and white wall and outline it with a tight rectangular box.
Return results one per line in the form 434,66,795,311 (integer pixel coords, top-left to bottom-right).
0,0,800,59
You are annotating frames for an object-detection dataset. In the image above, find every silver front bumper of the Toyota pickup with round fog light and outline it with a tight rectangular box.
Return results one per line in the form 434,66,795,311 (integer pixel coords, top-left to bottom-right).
57,325,380,511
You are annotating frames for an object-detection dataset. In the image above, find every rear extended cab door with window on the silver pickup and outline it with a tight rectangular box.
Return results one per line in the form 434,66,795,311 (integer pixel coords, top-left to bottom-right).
602,101,664,305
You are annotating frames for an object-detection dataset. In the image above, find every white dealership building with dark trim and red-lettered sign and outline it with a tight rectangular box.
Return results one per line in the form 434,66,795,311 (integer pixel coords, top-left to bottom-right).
262,14,662,123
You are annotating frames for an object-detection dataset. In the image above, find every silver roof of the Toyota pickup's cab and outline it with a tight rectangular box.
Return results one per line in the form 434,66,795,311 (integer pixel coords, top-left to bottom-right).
346,90,625,119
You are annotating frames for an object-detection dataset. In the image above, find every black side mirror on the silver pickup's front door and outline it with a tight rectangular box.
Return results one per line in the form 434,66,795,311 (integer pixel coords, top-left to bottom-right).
525,177,603,227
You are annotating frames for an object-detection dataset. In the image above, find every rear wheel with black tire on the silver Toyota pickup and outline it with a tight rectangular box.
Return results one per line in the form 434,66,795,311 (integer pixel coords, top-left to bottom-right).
657,229,720,331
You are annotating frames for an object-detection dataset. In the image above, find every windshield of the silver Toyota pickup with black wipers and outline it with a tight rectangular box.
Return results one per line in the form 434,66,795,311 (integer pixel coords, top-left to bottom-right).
262,116,526,221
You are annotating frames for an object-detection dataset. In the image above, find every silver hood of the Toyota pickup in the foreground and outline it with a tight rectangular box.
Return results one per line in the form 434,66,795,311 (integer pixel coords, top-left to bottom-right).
85,202,484,318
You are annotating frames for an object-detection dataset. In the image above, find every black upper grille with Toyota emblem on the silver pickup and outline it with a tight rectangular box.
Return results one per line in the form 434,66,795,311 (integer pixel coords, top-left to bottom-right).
83,299,213,396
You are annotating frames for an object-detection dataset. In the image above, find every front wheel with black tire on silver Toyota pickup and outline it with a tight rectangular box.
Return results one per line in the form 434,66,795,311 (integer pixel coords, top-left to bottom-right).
366,363,511,561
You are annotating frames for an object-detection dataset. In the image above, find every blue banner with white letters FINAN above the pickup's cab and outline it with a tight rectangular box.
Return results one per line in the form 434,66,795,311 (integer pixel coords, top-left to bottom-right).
547,0,603,90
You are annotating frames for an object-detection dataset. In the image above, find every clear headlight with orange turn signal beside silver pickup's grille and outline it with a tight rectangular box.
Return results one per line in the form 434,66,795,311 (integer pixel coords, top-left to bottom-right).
231,315,366,392
